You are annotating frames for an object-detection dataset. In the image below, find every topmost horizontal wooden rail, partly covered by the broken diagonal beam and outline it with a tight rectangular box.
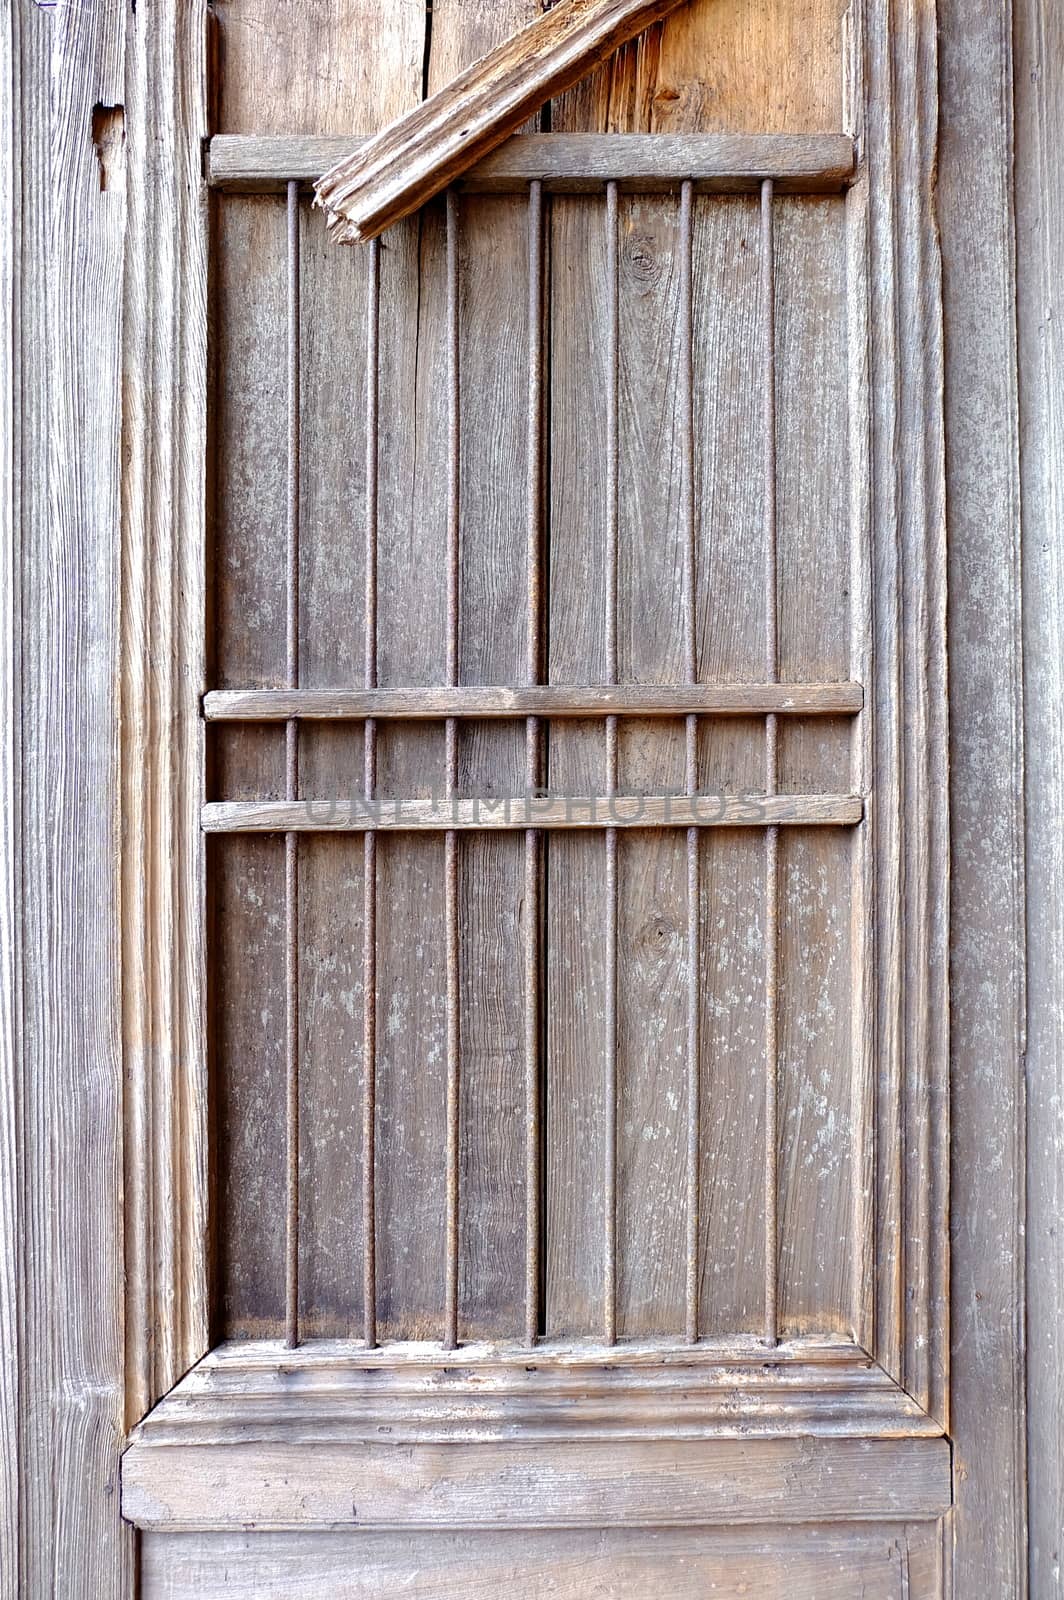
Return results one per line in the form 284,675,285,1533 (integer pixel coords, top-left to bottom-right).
206,133,854,194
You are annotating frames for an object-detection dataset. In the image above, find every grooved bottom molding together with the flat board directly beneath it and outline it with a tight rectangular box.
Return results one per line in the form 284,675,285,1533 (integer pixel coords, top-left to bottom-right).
122,1338,950,1531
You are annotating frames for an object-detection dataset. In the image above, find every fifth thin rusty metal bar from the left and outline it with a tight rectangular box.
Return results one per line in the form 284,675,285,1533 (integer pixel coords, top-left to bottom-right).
603,182,621,1344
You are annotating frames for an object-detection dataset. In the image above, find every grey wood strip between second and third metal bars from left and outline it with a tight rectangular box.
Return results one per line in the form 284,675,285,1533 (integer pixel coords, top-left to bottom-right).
369,208,446,1339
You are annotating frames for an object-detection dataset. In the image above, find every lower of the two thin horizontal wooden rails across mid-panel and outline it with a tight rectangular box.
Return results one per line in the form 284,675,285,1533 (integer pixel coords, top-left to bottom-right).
202,794,864,834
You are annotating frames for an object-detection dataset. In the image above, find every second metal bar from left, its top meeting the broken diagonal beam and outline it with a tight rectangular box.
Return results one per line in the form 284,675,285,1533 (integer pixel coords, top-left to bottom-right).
362,238,381,1349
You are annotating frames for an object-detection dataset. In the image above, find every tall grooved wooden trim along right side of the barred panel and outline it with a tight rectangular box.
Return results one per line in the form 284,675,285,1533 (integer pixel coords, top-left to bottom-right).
846,0,949,1426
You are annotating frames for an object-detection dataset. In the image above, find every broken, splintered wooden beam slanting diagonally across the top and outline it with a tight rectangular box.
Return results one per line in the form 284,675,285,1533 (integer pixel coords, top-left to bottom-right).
315,0,697,243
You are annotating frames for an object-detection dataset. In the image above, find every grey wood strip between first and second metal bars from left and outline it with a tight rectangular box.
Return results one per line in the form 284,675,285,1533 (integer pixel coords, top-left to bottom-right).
299,203,368,1336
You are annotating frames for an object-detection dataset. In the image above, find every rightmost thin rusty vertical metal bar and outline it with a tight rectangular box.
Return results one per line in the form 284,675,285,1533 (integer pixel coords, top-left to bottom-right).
760,178,779,1346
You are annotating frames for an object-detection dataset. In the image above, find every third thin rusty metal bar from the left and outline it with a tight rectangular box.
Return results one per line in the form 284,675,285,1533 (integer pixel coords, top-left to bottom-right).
443,189,461,1350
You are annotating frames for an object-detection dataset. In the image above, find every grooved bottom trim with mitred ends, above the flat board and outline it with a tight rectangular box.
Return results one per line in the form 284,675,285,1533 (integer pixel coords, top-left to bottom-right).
120,1338,941,1450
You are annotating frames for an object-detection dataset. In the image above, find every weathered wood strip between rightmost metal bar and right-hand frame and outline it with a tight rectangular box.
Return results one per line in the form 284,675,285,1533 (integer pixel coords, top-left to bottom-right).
774,197,854,1333
